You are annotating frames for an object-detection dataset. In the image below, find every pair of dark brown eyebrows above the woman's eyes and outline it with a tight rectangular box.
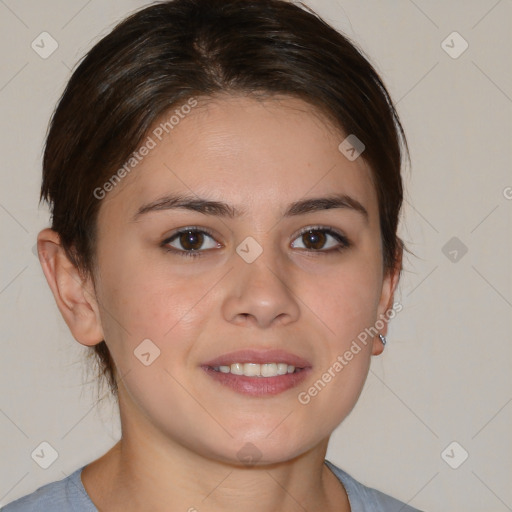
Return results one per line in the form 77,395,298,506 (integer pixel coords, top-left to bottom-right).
132,194,368,222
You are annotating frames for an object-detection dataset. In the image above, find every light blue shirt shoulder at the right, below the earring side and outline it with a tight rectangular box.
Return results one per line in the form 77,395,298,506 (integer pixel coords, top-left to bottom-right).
325,460,421,512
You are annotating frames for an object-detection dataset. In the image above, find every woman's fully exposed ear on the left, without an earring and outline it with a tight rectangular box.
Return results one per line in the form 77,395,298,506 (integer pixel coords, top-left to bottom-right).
37,228,104,346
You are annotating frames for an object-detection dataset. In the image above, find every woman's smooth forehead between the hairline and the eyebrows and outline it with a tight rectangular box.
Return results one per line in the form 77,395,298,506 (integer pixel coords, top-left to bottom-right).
100,93,377,224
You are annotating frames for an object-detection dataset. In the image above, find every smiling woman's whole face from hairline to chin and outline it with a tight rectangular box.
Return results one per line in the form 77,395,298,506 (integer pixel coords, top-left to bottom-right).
90,97,396,463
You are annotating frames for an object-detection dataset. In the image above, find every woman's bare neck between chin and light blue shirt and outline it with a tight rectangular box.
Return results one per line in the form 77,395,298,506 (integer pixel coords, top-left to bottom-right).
82,430,350,512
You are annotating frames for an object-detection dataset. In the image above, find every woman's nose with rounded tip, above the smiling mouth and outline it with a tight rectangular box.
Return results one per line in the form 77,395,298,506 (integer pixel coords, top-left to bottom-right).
222,243,300,328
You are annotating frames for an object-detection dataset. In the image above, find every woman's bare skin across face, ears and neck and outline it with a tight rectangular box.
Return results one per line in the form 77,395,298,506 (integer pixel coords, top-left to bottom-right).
38,97,399,512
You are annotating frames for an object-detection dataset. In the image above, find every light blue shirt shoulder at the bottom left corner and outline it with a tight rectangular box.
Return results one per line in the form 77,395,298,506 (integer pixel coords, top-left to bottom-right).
0,467,97,512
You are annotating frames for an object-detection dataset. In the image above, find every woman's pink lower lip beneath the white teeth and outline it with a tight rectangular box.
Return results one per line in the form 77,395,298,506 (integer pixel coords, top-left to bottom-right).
202,367,310,396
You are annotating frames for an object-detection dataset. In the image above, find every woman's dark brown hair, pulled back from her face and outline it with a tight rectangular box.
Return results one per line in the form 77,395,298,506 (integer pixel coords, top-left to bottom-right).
41,0,408,404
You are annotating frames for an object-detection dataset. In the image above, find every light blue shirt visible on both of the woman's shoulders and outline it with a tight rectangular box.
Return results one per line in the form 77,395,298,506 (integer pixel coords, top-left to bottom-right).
0,461,420,512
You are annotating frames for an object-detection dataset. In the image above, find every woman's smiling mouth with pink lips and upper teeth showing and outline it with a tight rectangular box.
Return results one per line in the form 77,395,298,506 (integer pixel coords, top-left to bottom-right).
201,350,311,396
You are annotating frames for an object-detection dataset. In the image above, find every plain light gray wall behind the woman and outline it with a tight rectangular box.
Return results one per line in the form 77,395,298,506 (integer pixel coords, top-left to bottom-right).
0,0,512,512
